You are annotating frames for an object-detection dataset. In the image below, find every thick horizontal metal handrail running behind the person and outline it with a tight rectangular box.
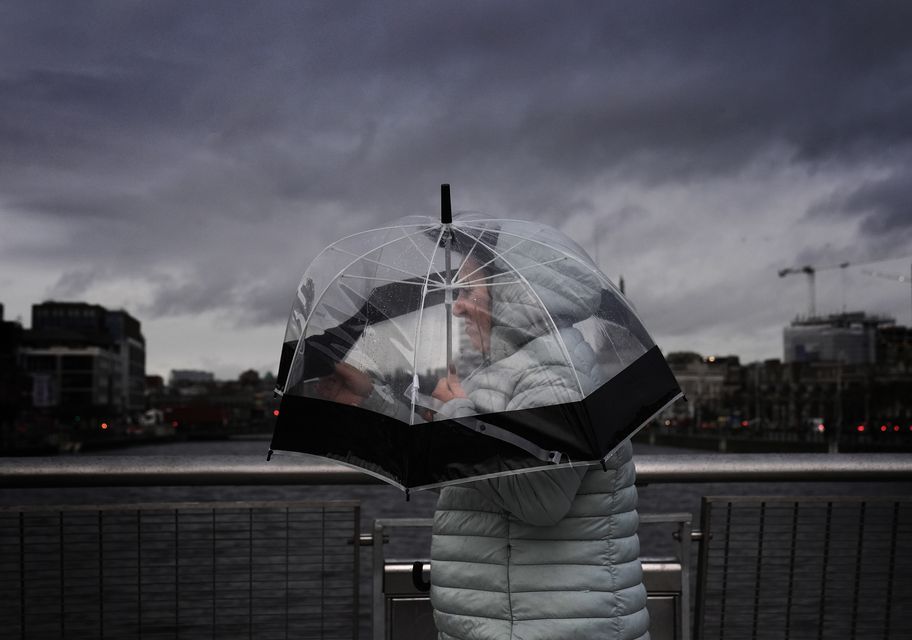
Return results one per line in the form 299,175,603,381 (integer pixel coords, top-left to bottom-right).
0,453,912,488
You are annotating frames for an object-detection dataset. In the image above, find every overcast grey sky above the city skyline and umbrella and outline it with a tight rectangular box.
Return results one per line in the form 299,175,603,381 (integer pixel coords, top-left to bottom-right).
0,0,912,377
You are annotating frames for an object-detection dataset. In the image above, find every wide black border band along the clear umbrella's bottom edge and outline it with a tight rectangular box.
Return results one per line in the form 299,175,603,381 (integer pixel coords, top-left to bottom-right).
270,347,683,490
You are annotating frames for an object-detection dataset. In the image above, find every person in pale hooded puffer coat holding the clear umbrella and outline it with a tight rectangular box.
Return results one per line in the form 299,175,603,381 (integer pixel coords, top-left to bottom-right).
318,235,649,640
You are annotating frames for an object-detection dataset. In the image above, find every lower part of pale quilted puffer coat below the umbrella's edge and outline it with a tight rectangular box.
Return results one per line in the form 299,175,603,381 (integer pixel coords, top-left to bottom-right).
431,442,649,640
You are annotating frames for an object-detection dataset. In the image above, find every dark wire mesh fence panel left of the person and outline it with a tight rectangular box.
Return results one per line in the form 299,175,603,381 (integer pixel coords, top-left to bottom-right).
0,501,360,639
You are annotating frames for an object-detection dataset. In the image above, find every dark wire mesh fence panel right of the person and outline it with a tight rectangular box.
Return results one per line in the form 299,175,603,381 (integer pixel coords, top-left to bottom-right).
696,496,912,640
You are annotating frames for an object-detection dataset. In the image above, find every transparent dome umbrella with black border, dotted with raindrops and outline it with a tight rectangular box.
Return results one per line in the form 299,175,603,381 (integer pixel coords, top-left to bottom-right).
270,185,682,490
